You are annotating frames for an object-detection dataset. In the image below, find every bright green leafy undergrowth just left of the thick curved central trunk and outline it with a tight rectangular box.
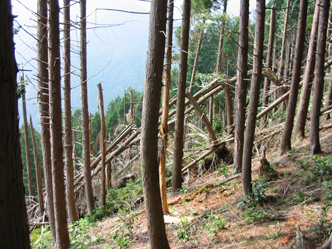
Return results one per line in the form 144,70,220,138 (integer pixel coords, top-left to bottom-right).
106,180,143,213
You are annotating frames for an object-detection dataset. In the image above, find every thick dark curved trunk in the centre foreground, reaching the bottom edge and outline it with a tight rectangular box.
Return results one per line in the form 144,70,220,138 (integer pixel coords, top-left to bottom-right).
141,0,170,249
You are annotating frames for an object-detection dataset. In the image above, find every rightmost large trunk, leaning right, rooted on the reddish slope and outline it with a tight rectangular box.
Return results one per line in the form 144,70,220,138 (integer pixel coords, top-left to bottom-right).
310,0,330,155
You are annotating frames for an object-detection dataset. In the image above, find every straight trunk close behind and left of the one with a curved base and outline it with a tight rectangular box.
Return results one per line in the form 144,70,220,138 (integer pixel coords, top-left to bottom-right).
234,0,249,173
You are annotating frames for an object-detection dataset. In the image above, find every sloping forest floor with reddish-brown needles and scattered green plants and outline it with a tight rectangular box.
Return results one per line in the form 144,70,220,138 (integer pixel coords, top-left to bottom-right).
90,121,332,249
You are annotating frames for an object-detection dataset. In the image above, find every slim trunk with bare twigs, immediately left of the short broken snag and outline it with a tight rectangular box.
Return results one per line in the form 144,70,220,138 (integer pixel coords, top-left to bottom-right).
80,0,94,216
